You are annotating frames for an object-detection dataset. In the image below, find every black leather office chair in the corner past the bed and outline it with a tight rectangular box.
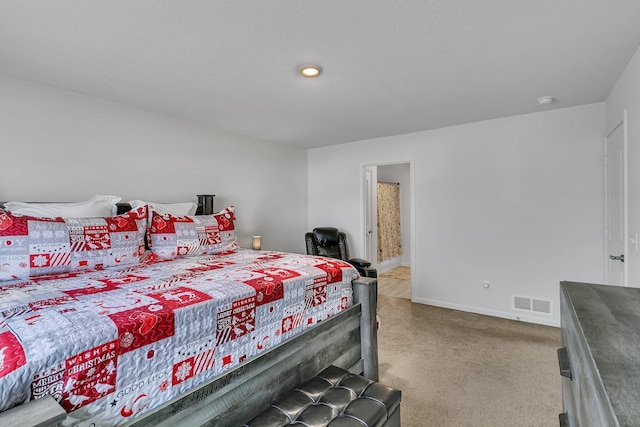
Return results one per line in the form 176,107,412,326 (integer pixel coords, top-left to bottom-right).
304,227,378,277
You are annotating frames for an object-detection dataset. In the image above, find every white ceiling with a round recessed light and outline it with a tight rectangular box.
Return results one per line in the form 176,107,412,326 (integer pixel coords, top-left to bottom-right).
0,0,640,147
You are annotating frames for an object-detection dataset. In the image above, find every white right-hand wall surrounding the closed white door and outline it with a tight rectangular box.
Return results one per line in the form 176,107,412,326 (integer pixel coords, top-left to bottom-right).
606,48,640,287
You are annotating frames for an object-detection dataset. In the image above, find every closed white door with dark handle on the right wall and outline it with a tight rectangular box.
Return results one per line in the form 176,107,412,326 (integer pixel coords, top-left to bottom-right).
605,121,627,286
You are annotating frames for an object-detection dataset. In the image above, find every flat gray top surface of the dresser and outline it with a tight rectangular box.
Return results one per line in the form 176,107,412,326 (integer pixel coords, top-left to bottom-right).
560,282,640,426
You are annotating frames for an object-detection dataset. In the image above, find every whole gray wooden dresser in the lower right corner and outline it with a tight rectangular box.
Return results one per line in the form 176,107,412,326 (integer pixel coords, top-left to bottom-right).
558,282,640,427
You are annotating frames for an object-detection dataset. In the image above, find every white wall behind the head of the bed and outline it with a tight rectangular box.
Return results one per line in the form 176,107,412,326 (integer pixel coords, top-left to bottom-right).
0,76,307,253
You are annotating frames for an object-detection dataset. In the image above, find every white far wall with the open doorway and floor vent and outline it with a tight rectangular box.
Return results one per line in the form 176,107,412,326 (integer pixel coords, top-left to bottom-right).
308,103,604,325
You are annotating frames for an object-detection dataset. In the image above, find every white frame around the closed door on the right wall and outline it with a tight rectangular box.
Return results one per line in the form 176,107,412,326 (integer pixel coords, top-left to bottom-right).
603,109,630,286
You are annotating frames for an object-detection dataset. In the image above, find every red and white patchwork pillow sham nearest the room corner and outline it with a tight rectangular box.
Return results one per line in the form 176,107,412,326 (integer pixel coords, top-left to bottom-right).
148,206,238,259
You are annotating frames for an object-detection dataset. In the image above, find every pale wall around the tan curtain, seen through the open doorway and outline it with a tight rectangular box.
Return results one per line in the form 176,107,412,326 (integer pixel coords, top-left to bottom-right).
378,163,411,272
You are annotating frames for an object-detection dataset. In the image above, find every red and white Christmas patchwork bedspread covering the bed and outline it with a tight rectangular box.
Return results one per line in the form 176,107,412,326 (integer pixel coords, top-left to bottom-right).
0,250,357,426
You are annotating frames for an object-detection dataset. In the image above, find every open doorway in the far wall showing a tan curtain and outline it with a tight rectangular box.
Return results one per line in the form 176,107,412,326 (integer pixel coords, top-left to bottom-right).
363,161,413,299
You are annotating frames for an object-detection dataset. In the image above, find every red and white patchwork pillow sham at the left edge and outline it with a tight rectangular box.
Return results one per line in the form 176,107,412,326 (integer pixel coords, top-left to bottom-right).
0,207,147,281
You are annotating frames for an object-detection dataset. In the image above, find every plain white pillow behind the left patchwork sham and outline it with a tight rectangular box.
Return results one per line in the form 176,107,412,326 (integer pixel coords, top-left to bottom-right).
4,196,122,218
